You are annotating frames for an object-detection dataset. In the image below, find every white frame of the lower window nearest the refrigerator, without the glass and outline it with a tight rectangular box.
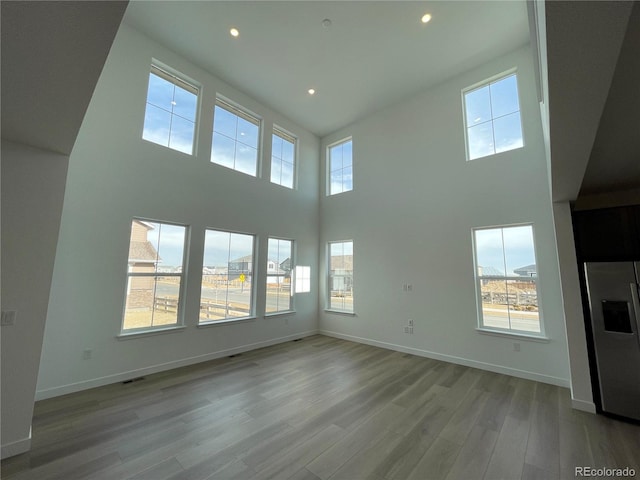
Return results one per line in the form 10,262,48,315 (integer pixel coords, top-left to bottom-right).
471,222,549,341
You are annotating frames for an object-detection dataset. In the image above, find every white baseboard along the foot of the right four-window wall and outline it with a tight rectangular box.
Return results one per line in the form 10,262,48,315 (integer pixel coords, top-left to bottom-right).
318,329,569,388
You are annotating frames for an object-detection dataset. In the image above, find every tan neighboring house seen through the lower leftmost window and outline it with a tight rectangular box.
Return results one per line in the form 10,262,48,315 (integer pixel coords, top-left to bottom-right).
126,220,160,310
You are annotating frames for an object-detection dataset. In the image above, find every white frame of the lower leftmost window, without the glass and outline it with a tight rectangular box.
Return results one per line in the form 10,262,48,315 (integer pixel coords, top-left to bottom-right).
118,217,191,337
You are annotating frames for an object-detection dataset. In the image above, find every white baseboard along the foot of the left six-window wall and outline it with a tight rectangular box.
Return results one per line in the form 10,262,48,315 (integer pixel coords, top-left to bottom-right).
33,330,318,402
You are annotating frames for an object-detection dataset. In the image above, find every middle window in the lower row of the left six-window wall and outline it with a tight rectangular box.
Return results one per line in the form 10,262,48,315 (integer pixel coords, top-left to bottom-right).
200,230,254,323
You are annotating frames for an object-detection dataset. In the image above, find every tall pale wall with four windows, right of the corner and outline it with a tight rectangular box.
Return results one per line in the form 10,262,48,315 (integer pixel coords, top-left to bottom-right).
320,48,570,385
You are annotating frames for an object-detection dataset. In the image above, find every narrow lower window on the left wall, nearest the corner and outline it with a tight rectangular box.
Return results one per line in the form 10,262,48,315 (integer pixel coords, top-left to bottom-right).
265,238,293,313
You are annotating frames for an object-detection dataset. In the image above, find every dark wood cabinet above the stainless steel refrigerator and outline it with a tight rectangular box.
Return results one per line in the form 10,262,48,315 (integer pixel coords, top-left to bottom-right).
573,205,640,263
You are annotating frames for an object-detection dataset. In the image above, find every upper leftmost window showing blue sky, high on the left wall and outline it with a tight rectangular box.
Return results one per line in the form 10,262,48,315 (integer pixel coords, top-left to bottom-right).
142,65,198,155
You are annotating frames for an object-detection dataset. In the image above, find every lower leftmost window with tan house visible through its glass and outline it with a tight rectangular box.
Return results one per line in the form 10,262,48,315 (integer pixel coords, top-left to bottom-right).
122,218,187,331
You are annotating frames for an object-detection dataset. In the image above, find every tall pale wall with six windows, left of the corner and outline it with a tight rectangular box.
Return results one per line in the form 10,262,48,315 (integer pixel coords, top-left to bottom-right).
38,25,319,398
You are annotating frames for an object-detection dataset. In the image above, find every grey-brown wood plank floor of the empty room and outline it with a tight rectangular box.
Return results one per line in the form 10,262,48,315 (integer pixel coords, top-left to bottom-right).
2,336,640,480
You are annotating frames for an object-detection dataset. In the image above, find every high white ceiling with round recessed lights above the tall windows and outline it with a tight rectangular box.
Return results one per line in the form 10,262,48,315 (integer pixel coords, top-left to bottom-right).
124,0,529,137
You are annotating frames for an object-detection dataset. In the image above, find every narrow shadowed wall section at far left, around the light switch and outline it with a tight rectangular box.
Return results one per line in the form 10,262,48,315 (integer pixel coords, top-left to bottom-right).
1,140,69,458
